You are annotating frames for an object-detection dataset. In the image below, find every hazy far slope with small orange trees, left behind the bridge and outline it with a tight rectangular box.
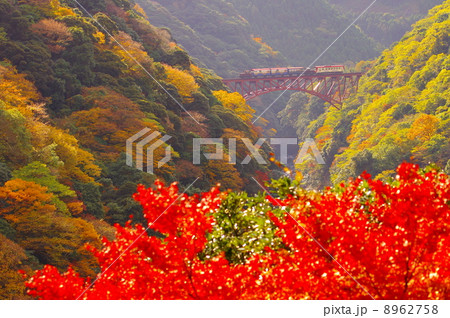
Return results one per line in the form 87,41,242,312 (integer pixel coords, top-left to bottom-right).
138,0,286,77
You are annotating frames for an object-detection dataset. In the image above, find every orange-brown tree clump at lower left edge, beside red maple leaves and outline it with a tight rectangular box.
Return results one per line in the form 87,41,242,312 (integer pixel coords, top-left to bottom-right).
0,179,100,275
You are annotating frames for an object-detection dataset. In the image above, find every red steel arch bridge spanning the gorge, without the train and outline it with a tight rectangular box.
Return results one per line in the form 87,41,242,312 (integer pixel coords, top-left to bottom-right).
222,73,363,109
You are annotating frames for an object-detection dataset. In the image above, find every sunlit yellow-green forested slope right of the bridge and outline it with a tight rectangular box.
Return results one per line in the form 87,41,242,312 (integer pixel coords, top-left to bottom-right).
290,0,450,188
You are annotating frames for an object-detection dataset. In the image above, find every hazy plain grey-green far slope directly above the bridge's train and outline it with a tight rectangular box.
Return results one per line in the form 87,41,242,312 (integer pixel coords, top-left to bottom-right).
230,0,379,66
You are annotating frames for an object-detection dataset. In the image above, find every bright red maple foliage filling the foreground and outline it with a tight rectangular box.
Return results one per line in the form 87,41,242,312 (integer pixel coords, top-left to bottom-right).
27,164,450,299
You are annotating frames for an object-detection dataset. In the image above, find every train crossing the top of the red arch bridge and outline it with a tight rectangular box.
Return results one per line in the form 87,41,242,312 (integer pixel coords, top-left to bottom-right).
239,65,345,79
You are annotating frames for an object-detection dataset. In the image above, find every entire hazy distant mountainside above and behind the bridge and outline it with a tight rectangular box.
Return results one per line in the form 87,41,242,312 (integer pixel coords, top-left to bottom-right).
137,0,442,77
